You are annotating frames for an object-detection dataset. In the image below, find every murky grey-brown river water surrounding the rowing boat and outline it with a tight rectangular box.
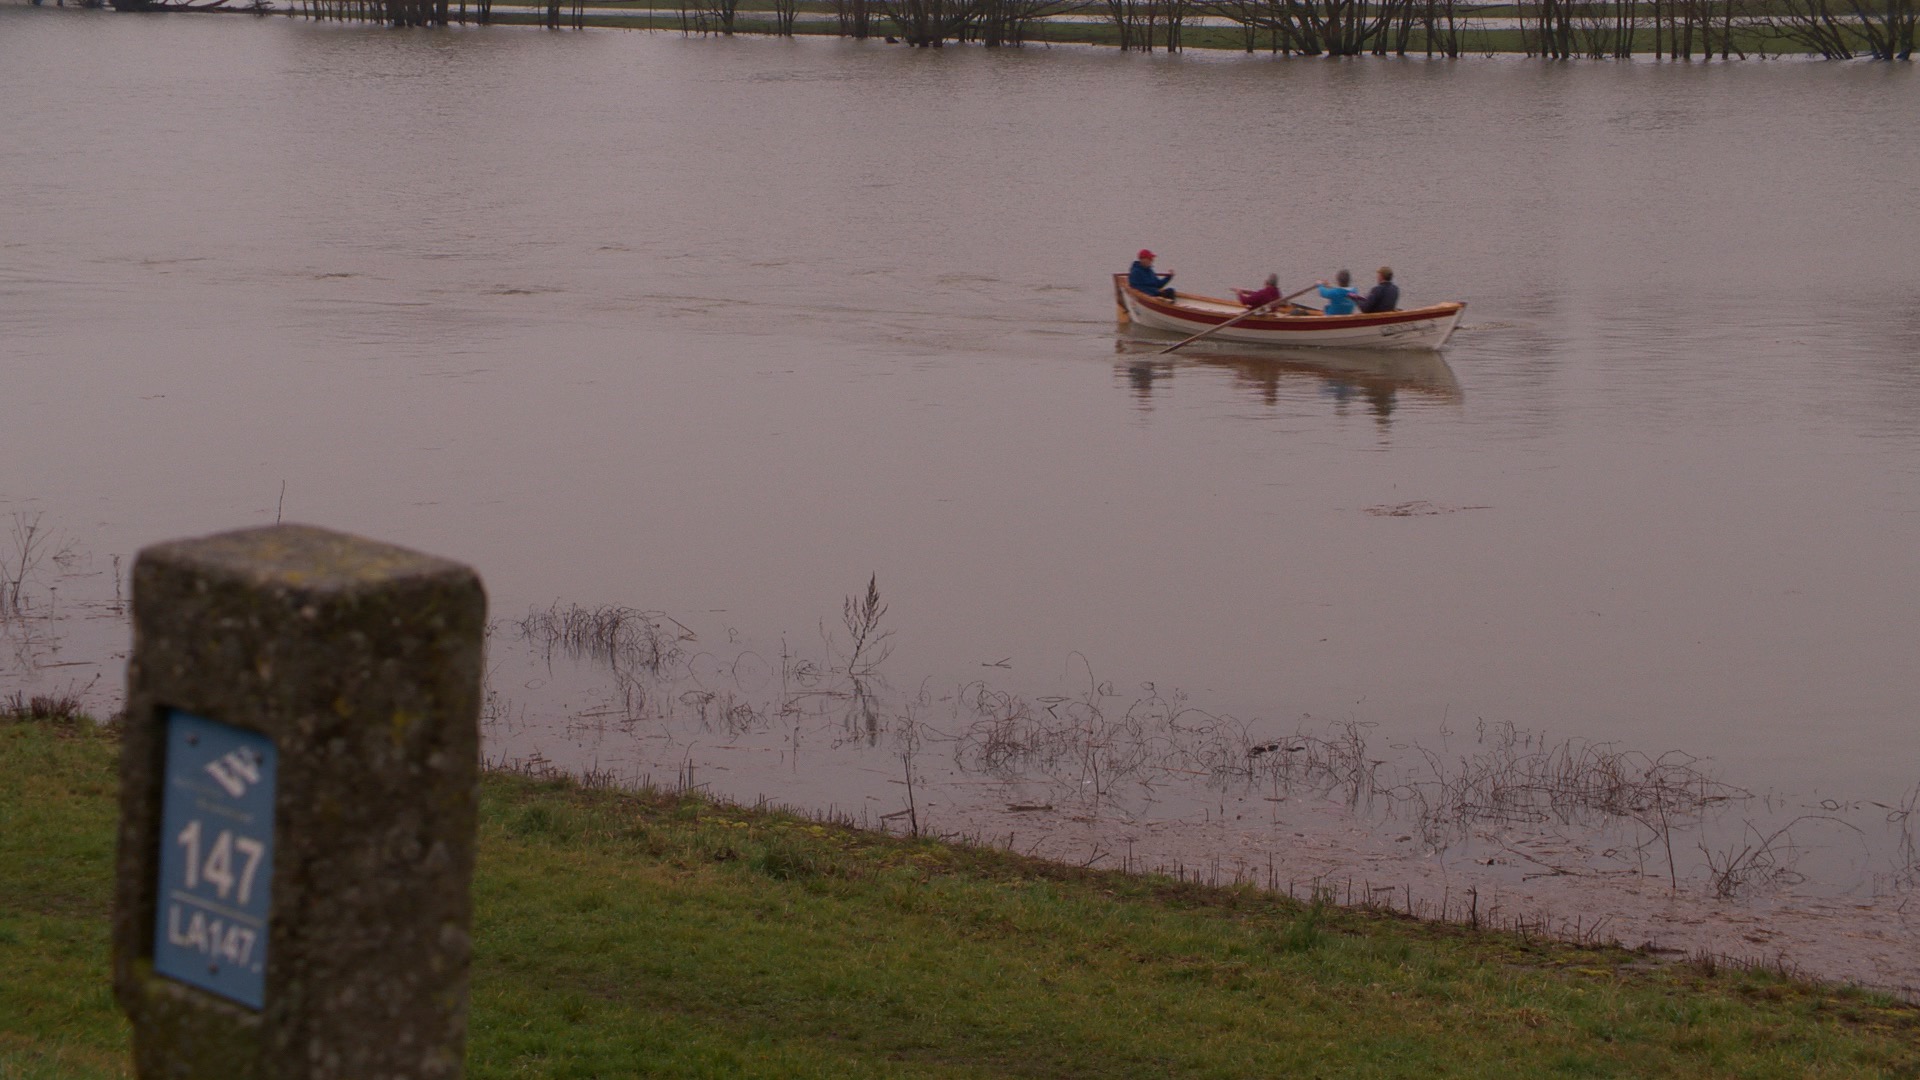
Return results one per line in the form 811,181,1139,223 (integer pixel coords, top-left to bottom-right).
0,6,1920,984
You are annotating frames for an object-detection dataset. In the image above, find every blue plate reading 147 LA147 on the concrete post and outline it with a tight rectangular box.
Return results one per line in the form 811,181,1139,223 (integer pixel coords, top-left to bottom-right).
154,709,278,1009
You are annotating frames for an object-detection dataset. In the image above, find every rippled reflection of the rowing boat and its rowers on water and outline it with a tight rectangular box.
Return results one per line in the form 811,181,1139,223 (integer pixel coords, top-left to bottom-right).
1114,338,1461,425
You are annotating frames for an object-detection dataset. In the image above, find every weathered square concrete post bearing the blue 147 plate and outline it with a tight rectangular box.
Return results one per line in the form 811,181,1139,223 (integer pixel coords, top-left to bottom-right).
113,525,486,1080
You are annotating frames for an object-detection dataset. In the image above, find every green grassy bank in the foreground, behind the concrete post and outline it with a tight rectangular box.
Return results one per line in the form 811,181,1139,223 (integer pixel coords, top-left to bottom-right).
0,707,1920,1078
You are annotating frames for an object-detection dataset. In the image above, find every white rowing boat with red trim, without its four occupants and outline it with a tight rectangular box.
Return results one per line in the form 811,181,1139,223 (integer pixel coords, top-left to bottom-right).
1114,273,1467,350
